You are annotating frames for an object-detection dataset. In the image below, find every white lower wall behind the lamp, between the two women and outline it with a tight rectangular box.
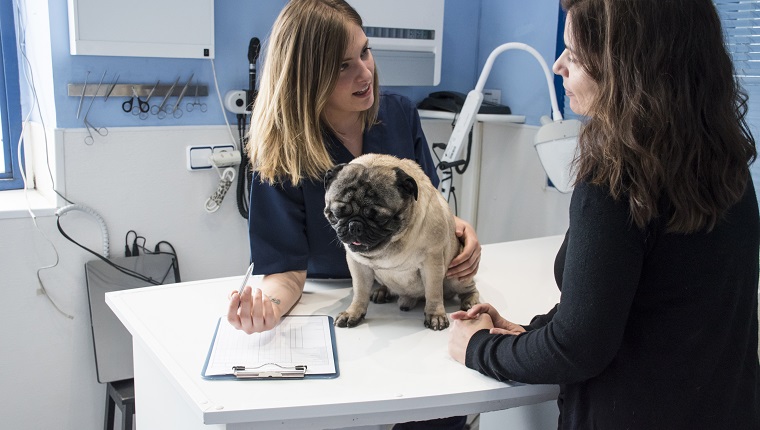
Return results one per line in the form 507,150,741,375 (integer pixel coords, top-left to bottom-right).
422,119,571,244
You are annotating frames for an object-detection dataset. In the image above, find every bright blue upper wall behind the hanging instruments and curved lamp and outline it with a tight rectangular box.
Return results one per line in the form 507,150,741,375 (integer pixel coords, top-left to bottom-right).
44,0,558,128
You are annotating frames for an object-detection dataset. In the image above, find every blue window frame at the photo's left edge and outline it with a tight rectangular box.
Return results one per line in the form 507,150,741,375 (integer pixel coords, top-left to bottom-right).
0,1,24,191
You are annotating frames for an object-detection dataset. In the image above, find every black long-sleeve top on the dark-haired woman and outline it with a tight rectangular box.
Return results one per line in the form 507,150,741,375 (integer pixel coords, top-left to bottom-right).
465,182,760,430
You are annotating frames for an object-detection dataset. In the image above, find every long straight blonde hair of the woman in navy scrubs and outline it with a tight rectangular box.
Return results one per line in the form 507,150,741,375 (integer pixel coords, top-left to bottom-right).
247,0,379,185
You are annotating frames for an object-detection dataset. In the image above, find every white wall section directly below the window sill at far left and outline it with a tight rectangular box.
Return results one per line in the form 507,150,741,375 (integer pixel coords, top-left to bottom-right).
0,217,105,430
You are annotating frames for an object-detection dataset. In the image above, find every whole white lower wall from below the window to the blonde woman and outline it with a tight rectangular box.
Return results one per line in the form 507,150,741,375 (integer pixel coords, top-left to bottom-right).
0,122,249,430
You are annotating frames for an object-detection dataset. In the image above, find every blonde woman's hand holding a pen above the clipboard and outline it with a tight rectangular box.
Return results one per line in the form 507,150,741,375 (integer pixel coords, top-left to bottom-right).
227,263,279,334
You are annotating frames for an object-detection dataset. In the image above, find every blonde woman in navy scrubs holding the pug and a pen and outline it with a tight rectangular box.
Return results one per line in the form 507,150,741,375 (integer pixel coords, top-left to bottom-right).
228,0,480,428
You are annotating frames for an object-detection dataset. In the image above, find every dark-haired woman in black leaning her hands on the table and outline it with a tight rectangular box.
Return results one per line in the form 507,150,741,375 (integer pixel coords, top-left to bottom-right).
449,0,760,430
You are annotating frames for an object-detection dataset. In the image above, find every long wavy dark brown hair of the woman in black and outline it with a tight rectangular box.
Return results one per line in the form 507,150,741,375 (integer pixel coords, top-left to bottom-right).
562,0,757,233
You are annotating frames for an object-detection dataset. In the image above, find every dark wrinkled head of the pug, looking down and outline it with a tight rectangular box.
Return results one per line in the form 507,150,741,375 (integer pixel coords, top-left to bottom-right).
324,164,417,253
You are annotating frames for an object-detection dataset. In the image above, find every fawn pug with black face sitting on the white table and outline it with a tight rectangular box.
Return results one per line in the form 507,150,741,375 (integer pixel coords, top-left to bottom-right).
324,154,480,330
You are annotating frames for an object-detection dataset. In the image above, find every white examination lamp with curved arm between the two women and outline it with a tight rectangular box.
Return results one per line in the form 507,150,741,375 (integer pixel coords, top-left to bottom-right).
441,42,580,199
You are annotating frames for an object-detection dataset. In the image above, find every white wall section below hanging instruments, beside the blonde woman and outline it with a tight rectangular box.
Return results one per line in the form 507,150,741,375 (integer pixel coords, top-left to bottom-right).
63,126,249,280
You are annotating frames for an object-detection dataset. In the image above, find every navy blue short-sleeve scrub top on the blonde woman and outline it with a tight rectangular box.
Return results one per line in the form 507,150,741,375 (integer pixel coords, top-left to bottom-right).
248,93,438,278
